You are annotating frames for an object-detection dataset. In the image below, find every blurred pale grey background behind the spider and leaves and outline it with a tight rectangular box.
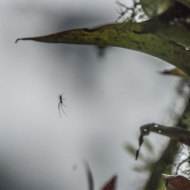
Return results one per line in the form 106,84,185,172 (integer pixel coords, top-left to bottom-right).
0,0,187,190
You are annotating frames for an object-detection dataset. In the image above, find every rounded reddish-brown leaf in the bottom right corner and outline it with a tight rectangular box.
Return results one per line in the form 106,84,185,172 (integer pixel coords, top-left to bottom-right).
162,174,190,190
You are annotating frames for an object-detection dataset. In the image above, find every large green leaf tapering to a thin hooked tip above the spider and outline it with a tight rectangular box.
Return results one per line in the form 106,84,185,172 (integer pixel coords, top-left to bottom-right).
16,19,190,74
